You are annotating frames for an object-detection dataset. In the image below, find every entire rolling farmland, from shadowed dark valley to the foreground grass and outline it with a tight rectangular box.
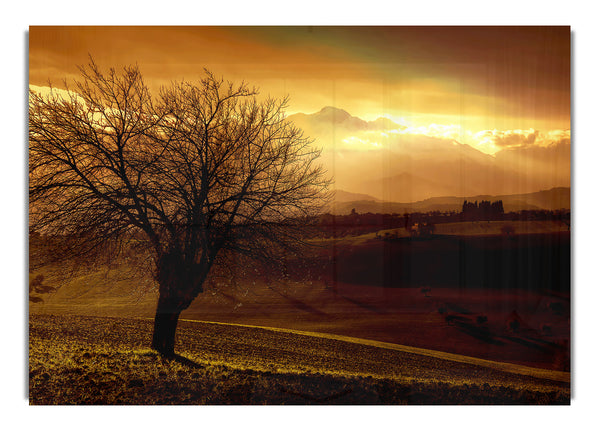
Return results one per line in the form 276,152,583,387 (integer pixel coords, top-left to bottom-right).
30,227,571,404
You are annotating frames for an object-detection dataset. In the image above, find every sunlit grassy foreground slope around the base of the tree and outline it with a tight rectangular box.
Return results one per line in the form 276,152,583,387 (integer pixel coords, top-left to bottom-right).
29,315,570,404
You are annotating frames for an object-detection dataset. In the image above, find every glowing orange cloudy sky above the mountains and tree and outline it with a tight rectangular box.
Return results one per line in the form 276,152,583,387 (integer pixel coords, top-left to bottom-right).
29,26,571,200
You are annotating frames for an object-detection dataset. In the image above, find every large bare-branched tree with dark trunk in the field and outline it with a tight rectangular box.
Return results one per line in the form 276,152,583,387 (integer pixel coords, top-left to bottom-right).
29,61,329,355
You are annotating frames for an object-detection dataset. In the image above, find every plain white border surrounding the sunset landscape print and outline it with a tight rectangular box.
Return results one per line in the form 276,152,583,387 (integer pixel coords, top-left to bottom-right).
5,0,600,431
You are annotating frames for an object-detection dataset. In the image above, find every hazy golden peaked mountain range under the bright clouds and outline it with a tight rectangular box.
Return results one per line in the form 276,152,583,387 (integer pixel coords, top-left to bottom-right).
288,107,570,202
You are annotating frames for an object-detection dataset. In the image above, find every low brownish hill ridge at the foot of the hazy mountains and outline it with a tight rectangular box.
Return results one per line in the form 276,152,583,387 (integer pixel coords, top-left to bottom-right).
330,187,571,214
